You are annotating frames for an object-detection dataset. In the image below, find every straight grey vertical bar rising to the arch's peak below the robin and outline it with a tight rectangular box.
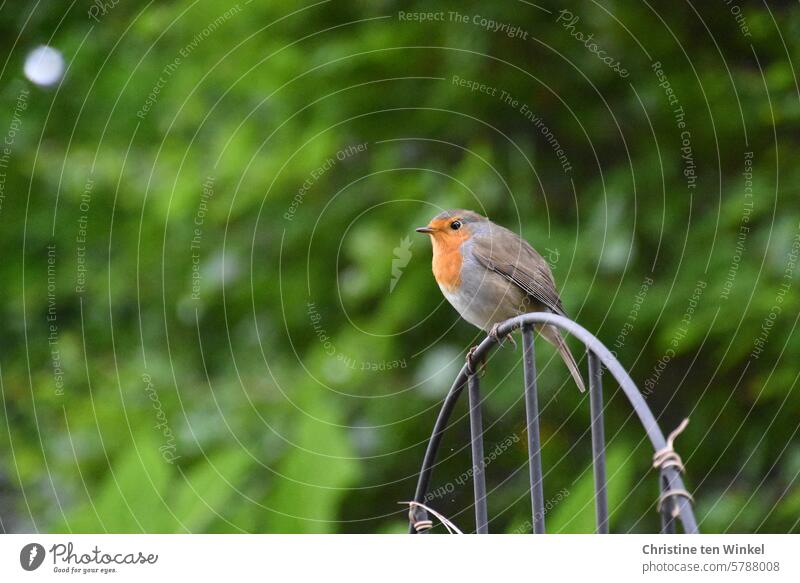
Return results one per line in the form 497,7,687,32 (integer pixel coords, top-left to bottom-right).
522,324,544,534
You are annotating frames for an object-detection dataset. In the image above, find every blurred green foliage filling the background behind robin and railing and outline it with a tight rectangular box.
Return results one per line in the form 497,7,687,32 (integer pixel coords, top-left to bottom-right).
0,0,800,532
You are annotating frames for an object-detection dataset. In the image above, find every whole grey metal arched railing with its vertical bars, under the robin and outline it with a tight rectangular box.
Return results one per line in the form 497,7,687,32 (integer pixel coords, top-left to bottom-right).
409,312,698,534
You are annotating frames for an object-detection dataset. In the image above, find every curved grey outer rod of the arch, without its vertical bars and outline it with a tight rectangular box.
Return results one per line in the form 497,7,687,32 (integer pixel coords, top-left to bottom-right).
409,312,698,534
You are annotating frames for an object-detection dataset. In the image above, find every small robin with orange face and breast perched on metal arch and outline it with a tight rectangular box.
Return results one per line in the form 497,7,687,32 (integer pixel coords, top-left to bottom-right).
417,209,585,391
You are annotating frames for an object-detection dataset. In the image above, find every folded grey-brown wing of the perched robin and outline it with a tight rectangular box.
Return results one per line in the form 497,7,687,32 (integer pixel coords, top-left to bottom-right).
472,227,567,316
